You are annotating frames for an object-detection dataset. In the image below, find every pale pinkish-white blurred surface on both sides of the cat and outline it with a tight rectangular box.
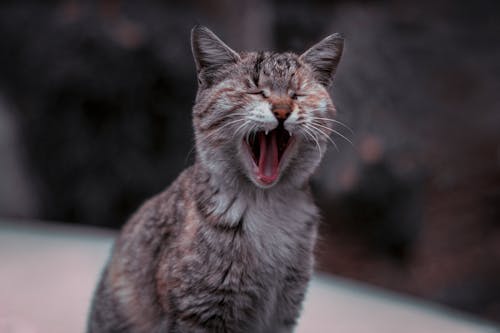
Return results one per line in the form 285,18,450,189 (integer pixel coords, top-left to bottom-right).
0,221,500,333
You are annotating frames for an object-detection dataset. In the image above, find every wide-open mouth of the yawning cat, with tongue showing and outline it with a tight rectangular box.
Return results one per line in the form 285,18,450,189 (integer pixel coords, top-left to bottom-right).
245,124,292,185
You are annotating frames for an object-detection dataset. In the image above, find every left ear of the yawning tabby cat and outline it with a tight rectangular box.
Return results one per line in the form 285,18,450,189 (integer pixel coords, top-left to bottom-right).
191,25,240,85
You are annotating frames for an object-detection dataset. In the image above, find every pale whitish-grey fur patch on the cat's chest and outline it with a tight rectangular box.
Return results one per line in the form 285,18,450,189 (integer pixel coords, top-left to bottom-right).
224,195,317,281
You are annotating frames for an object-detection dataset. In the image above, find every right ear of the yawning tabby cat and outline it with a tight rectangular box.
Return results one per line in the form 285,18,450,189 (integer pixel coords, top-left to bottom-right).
300,33,344,87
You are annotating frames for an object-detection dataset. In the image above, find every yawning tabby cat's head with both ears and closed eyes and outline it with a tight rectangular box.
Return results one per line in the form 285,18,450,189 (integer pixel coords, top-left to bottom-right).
191,26,343,188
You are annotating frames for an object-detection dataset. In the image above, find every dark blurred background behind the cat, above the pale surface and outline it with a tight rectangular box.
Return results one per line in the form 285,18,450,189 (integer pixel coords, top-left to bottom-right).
0,0,500,322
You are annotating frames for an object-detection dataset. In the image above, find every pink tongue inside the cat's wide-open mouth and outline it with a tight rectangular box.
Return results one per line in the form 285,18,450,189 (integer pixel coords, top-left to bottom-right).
259,131,279,184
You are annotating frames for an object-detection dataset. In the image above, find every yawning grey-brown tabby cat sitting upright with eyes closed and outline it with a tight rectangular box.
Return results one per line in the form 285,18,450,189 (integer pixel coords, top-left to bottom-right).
87,26,343,333
